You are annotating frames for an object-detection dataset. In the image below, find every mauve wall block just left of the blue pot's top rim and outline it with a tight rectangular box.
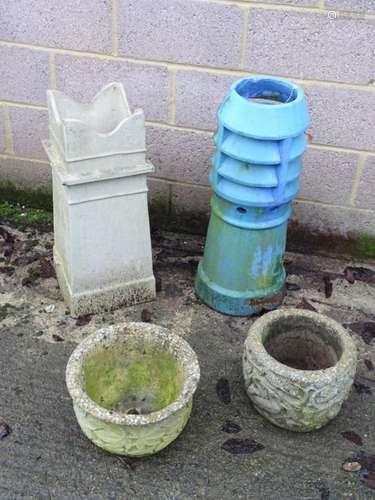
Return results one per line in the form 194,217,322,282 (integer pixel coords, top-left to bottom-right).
176,70,237,130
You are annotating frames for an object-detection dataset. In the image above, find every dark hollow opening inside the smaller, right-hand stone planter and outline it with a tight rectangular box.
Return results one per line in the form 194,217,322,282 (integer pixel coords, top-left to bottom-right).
264,318,342,370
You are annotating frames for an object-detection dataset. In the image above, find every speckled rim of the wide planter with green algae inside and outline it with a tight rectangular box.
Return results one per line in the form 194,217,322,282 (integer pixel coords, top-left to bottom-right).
66,322,200,426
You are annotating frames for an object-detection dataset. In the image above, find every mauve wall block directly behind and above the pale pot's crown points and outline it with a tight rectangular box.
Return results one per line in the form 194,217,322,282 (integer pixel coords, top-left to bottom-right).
56,55,170,121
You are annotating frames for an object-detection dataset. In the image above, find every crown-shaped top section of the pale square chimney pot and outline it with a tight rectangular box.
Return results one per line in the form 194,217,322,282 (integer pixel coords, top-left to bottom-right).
47,82,146,162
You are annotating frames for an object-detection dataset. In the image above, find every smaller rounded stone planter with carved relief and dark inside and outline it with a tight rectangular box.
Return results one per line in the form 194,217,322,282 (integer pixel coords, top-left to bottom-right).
243,309,357,432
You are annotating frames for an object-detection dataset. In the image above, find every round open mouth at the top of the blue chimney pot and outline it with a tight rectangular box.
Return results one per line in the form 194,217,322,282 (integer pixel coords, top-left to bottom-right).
236,78,298,104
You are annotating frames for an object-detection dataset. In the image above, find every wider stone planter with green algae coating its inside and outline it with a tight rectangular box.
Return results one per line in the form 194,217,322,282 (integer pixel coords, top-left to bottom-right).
66,323,199,457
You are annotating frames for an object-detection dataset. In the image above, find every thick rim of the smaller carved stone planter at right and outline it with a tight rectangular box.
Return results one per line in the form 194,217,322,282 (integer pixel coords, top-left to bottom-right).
245,308,357,383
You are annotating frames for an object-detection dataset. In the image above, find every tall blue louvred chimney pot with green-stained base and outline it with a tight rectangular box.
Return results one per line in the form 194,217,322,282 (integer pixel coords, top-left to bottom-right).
195,77,309,316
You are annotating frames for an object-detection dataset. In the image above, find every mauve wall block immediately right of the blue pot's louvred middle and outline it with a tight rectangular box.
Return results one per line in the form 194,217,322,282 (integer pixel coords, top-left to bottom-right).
299,148,358,205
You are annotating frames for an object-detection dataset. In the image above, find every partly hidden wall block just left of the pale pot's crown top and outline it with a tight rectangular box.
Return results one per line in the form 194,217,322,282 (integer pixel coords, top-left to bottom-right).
10,107,48,160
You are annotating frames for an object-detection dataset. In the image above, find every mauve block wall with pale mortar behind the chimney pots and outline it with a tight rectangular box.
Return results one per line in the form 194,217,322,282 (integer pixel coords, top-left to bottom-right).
0,0,375,254
